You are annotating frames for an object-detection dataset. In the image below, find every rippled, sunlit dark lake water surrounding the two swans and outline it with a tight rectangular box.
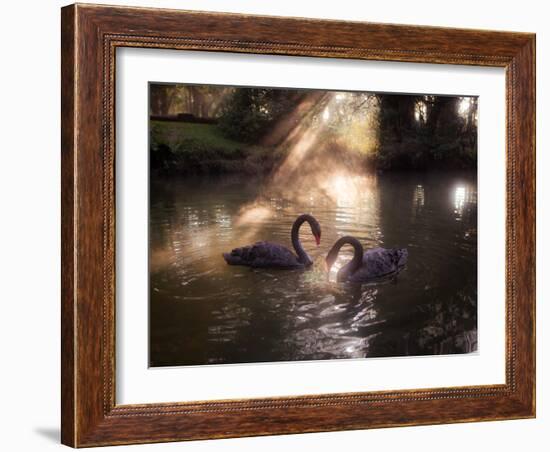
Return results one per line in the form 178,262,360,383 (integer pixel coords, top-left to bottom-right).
149,172,477,366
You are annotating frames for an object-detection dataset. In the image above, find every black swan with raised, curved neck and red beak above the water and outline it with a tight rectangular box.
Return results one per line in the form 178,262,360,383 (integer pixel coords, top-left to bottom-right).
223,214,321,269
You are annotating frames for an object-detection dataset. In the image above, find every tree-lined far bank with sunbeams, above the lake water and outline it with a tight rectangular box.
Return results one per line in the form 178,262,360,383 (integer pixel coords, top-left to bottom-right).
149,84,477,175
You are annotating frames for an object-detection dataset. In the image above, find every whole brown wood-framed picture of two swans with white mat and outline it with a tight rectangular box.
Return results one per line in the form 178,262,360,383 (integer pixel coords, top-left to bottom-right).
61,4,535,447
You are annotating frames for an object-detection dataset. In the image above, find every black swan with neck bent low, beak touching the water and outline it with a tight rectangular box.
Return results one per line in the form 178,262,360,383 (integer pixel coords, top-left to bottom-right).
326,236,408,282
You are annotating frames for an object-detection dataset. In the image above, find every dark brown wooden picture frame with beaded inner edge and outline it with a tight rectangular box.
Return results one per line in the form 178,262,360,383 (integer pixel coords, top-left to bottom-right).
61,4,535,447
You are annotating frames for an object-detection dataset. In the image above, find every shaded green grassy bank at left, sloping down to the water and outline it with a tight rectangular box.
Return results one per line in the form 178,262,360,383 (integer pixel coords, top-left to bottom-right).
150,121,283,174
